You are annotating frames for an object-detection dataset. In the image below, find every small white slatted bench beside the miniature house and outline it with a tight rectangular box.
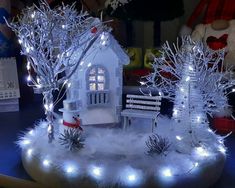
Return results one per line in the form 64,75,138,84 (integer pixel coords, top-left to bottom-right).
121,94,161,132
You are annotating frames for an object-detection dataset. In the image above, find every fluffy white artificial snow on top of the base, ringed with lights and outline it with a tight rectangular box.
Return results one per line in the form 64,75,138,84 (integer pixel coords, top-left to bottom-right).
19,117,224,186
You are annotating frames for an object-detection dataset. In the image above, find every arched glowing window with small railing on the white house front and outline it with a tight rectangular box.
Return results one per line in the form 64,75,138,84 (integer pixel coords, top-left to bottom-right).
87,65,109,106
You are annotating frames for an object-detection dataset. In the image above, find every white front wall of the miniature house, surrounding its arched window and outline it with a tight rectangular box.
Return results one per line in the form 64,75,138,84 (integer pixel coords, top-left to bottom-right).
69,48,122,125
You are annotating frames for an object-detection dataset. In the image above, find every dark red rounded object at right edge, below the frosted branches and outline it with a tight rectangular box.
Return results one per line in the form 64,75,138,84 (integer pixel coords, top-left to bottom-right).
212,117,235,133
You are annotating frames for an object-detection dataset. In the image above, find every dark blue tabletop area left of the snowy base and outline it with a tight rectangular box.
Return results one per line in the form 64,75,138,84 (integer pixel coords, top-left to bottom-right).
0,99,43,179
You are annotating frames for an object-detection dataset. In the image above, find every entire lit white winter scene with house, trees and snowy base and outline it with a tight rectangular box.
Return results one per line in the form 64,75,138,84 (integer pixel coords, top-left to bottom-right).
9,1,231,188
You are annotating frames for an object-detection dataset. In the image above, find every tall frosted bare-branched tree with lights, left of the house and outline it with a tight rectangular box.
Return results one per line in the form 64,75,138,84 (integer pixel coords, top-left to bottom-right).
8,0,105,142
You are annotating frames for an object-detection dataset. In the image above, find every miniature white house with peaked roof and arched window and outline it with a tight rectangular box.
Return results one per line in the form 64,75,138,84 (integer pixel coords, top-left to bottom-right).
63,29,129,128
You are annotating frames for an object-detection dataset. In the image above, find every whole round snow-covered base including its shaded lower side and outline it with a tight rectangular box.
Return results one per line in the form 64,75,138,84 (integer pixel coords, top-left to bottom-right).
19,117,225,187
